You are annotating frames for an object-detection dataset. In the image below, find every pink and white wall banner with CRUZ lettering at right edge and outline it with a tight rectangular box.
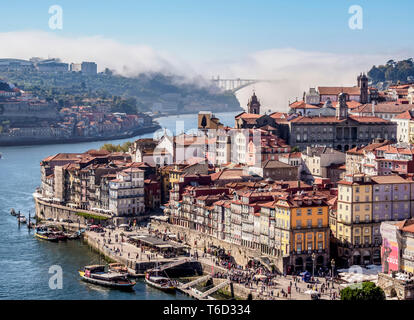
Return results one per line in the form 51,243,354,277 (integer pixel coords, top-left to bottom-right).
381,222,399,274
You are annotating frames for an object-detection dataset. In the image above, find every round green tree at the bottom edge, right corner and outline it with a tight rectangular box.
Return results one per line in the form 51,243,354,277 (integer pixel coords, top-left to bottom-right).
341,281,385,301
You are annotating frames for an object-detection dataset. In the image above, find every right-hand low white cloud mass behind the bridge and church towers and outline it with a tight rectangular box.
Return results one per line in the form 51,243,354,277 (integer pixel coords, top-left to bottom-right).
204,48,408,111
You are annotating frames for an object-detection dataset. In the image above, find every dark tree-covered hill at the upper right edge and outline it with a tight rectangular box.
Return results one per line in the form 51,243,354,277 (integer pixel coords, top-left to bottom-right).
368,58,414,89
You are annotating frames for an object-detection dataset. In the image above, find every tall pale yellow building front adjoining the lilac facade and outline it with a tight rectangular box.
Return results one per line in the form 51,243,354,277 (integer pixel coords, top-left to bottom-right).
336,174,373,265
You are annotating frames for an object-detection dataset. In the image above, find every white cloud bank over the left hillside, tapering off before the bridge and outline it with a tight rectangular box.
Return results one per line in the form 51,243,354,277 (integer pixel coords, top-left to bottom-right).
0,31,192,76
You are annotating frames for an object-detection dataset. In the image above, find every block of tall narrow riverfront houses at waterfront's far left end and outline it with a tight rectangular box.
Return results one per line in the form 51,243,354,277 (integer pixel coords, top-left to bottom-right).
38,150,152,224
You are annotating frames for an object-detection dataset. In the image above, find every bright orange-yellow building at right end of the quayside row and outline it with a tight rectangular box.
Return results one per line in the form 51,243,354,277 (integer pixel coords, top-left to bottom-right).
275,195,330,272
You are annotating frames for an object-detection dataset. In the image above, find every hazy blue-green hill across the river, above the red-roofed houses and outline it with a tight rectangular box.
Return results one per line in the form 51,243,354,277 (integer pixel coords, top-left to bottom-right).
0,71,241,113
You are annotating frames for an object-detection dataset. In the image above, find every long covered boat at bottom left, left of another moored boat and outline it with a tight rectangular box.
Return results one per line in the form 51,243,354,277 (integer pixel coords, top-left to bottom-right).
79,265,136,290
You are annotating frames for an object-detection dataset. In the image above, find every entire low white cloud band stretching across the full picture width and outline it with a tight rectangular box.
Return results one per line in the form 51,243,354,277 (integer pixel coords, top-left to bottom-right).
0,31,410,112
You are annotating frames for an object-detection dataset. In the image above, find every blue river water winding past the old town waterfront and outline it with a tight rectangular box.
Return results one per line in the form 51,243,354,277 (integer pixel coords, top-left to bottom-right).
0,112,237,300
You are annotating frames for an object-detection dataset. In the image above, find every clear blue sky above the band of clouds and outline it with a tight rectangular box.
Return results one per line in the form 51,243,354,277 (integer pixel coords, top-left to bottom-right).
0,0,414,61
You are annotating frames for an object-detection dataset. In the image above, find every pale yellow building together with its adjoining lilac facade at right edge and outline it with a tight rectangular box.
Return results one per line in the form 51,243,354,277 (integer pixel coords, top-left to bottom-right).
335,174,414,265
